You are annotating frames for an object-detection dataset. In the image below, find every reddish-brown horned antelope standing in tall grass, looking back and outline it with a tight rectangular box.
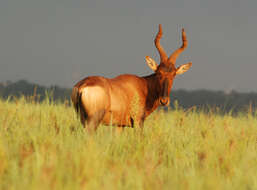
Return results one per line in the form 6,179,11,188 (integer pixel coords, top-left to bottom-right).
71,25,192,131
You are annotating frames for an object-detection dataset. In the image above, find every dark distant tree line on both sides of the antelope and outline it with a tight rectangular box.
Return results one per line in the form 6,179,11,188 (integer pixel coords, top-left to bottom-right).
0,80,257,112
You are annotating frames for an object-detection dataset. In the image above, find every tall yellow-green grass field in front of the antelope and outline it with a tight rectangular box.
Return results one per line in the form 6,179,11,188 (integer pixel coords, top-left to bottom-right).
0,98,257,190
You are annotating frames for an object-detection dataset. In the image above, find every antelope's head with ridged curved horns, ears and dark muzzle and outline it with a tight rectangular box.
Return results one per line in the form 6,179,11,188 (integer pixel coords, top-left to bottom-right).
146,25,192,106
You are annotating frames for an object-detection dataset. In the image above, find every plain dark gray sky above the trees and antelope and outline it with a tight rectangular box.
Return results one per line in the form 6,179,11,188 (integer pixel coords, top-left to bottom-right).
0,0,257,91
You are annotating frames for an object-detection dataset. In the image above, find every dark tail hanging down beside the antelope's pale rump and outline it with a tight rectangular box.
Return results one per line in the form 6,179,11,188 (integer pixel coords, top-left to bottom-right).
71,86,87,124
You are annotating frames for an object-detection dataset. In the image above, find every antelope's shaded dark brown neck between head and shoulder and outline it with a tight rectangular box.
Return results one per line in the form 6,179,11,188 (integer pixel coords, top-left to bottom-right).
143,74,160,115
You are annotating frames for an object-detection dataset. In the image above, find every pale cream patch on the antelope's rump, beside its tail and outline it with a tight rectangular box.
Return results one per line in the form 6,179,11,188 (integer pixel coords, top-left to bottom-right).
80,86,108,116
